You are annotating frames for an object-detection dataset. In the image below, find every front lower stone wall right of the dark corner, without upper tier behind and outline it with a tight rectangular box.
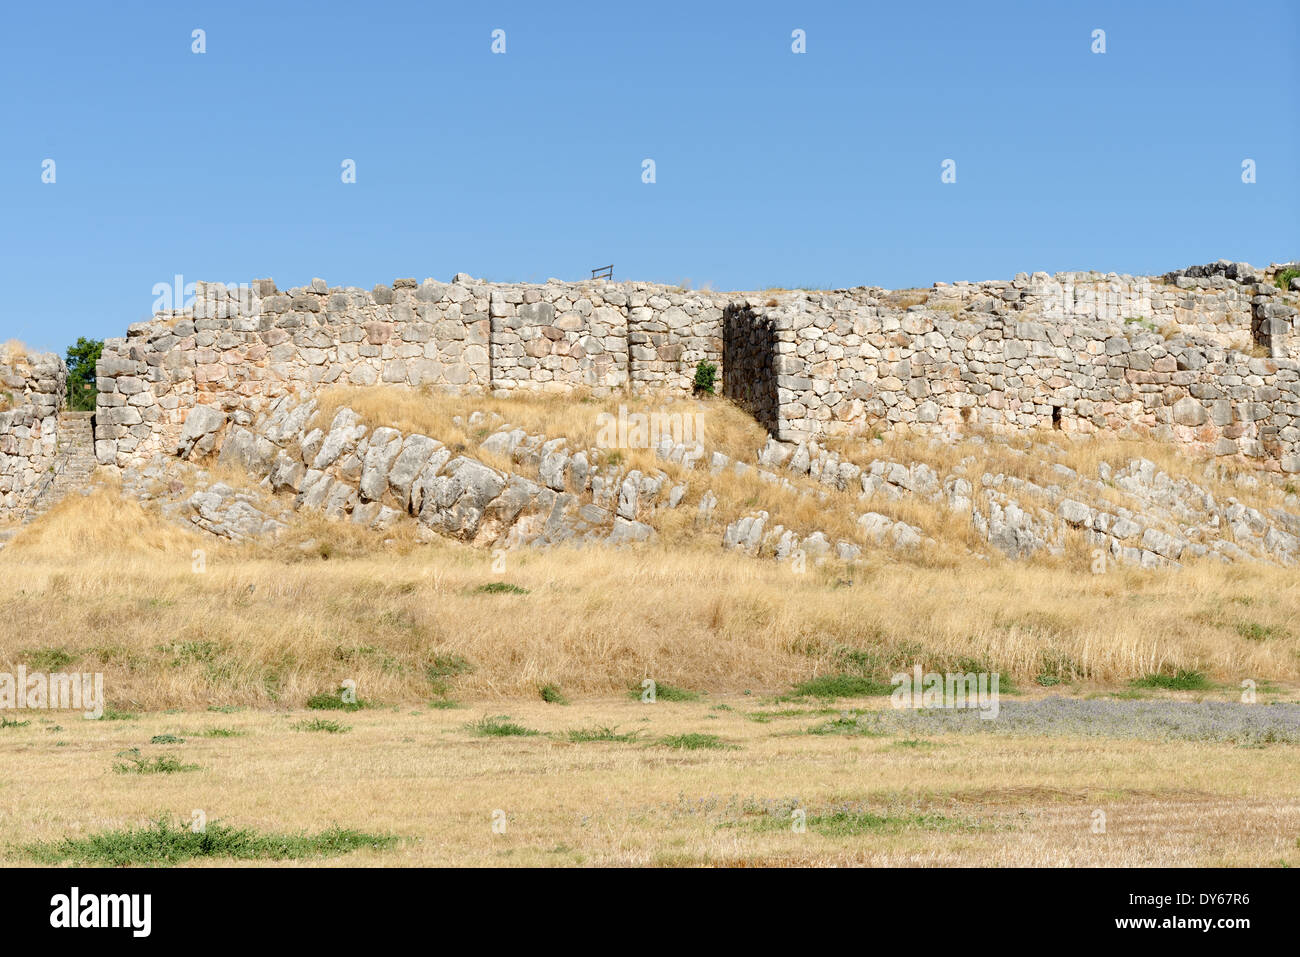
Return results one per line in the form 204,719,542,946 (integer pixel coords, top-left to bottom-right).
754,283,1300,472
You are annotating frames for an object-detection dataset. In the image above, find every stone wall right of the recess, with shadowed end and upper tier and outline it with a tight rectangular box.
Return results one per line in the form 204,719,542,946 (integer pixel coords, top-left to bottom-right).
727,268,1300,472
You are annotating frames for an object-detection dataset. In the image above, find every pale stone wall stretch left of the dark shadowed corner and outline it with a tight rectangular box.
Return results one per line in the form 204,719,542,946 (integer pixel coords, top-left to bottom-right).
96,274,729,465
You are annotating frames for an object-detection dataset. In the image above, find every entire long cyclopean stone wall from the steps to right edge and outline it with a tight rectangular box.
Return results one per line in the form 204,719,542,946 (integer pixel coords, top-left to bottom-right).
96,263,1300,472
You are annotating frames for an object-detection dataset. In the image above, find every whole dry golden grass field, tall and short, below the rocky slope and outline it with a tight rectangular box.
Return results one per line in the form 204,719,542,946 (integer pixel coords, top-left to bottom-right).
0,393,1300,866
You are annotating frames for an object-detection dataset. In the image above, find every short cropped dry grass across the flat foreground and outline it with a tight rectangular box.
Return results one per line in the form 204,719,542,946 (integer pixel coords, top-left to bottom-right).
0,697,1300,867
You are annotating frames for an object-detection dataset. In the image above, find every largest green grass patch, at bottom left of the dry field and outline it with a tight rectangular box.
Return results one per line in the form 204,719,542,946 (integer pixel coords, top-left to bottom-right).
26,820,397,867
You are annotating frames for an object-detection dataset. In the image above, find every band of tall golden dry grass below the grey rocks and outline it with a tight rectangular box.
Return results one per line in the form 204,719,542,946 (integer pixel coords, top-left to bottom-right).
0,481,1300,710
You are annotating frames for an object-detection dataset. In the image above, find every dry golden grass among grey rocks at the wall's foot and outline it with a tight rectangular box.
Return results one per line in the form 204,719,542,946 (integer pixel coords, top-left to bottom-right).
315,386,1284,561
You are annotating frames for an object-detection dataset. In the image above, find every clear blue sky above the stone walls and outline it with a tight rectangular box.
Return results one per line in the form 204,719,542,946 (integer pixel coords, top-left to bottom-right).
0,0,1300,351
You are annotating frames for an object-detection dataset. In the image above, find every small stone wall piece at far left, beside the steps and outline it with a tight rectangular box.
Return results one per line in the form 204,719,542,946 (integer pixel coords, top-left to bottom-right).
0,352,68,521
